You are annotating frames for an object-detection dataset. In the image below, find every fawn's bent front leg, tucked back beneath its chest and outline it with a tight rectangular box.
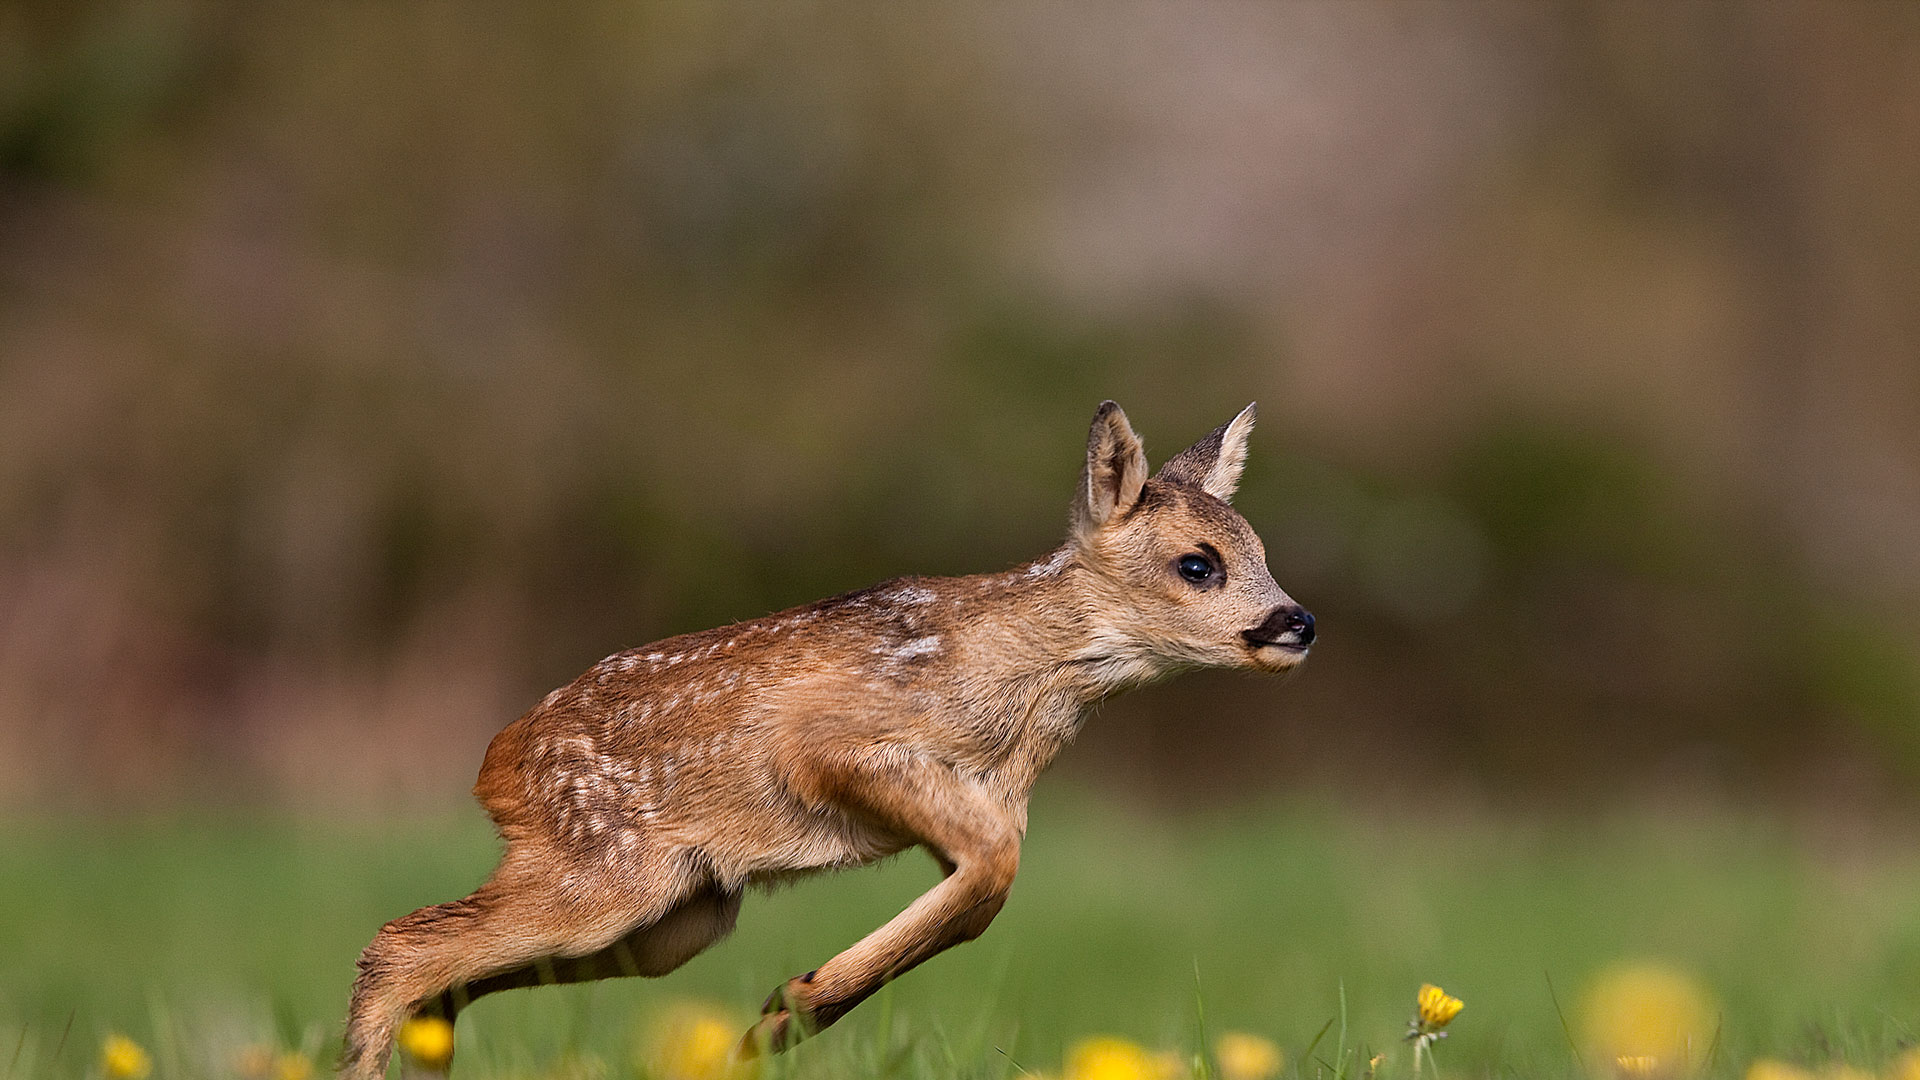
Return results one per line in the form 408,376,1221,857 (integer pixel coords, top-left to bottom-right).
741,751,1020,1055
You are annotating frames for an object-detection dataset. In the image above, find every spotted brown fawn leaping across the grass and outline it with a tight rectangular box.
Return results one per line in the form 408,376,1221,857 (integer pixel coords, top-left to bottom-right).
344,402,1313,1080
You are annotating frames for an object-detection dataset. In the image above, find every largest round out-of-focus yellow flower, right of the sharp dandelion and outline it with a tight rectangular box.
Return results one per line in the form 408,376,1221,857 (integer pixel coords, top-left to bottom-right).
1582,963,1715,1072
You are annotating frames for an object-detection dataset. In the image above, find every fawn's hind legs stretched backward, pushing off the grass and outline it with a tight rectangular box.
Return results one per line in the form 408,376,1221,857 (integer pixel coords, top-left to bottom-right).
342,842,718,1080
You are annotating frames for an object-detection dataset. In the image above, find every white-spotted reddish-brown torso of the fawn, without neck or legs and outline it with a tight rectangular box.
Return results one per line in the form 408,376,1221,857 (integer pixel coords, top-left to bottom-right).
474,578,972,876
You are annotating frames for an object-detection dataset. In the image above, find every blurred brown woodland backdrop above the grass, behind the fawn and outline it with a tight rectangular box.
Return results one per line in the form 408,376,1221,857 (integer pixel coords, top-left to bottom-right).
0,0,1920,809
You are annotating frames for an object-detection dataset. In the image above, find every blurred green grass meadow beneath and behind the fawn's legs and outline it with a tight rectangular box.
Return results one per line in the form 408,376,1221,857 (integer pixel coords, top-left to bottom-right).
0,796,1920,1080
